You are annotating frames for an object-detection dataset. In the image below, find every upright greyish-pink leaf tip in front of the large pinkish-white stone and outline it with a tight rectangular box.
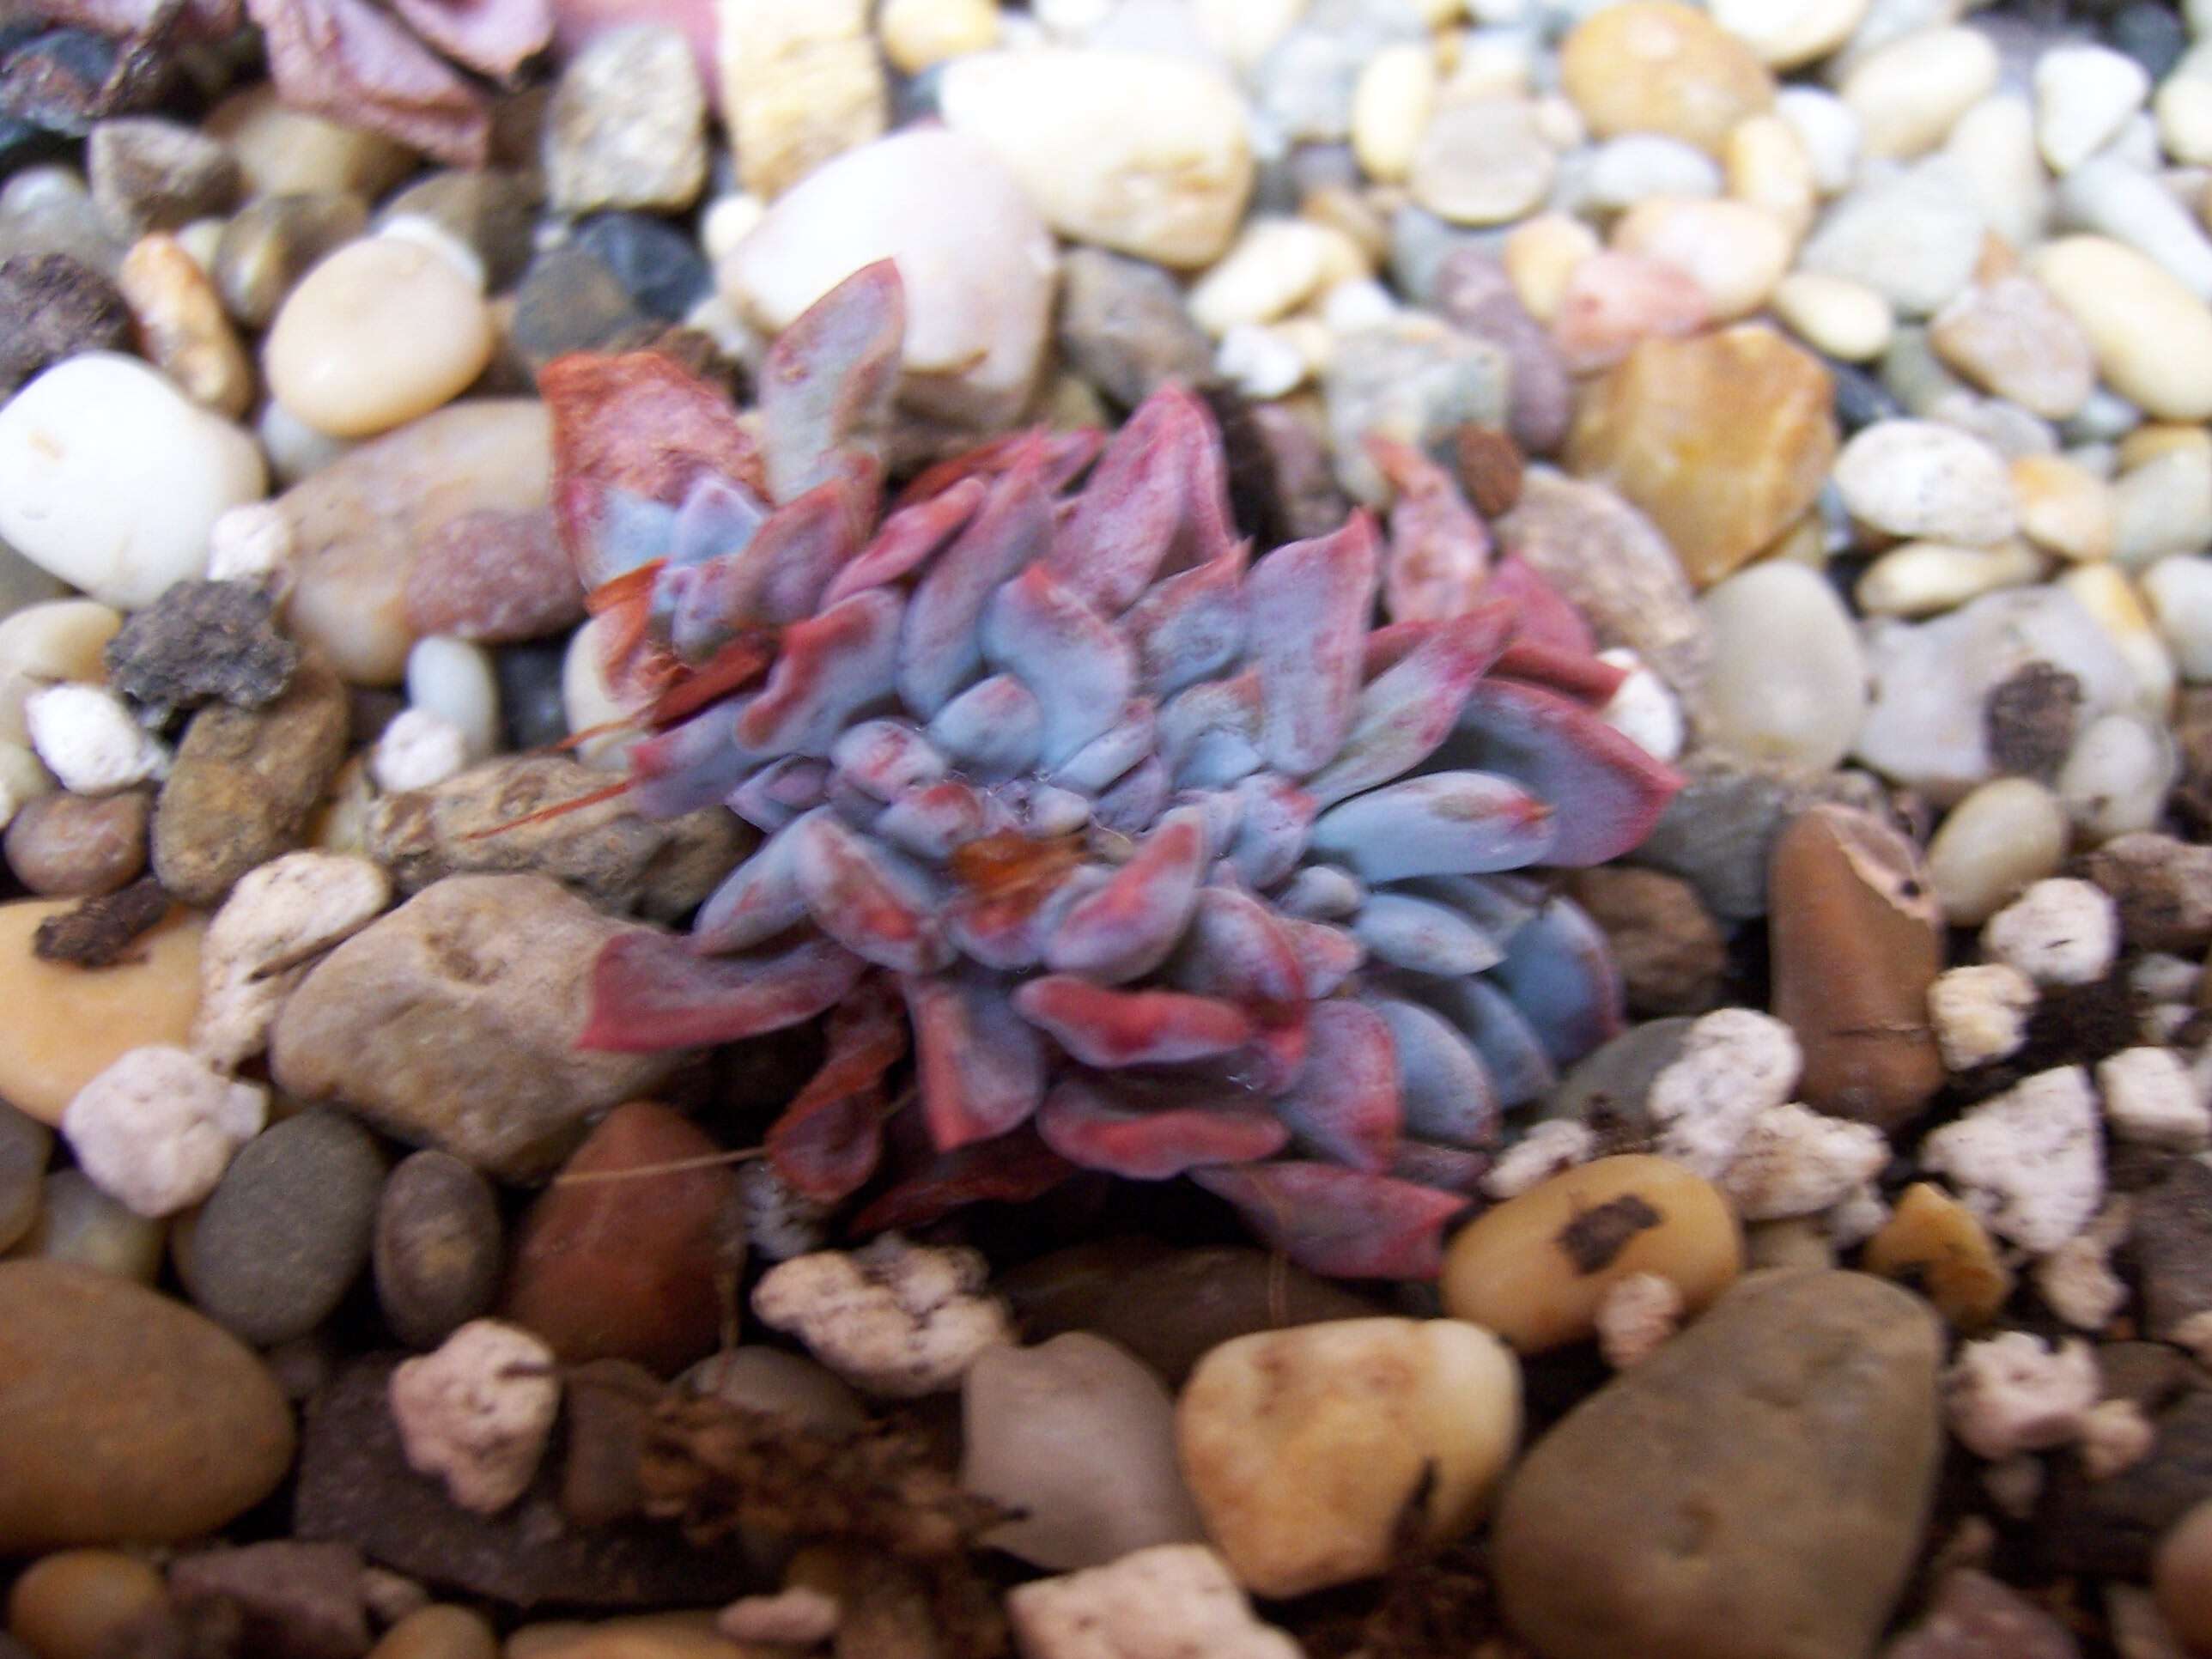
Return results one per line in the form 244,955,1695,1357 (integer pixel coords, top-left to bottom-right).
759,258,907,502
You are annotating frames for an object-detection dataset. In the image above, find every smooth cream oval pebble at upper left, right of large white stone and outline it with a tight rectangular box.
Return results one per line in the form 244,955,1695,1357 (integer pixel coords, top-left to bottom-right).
261,237,493,438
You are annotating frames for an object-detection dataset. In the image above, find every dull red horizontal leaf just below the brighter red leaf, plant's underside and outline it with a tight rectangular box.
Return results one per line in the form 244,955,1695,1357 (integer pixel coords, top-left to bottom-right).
1037,1073,1290,1182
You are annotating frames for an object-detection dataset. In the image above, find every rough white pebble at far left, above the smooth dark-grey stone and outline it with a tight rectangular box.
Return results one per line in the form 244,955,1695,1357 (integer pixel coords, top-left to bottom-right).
62,1044,268,1217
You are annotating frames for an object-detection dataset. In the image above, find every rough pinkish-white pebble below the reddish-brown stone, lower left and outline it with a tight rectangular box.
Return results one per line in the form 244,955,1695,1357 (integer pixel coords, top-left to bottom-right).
392,1318,560,1516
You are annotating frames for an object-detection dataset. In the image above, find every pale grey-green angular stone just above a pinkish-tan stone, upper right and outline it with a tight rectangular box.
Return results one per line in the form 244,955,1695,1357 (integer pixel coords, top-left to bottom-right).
1798,159,1984,316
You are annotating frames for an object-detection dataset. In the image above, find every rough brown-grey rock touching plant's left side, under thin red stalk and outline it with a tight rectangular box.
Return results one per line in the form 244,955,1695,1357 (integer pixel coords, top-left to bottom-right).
368,754,754,921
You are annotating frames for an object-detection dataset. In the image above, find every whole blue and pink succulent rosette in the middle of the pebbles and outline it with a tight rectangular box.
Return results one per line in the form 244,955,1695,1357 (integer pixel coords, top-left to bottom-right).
544,264,1677,1276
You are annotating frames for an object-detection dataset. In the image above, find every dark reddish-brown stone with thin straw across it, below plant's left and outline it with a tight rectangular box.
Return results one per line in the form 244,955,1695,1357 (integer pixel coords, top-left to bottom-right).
500,1102,737,1376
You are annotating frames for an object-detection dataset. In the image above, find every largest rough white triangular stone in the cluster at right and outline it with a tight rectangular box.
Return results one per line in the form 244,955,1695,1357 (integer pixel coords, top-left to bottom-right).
1920,1066,2104,1255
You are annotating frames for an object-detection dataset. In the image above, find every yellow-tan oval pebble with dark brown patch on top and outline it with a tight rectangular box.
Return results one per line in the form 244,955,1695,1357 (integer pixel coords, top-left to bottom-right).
1443,1155,1743,1354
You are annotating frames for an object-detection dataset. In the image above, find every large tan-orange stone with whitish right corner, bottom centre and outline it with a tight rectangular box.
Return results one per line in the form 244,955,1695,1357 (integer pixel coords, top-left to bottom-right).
1175,1318,1522,1597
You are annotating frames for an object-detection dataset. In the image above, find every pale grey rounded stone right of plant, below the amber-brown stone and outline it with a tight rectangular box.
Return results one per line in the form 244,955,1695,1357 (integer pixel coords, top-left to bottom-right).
1698,564,1867,772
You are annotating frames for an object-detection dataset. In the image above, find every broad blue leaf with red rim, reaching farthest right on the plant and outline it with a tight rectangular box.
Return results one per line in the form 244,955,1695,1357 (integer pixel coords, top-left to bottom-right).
1450,679,1681,874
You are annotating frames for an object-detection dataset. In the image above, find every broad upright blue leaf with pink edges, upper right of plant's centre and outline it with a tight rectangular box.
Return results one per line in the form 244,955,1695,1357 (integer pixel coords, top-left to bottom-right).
1245,514,1378,779
